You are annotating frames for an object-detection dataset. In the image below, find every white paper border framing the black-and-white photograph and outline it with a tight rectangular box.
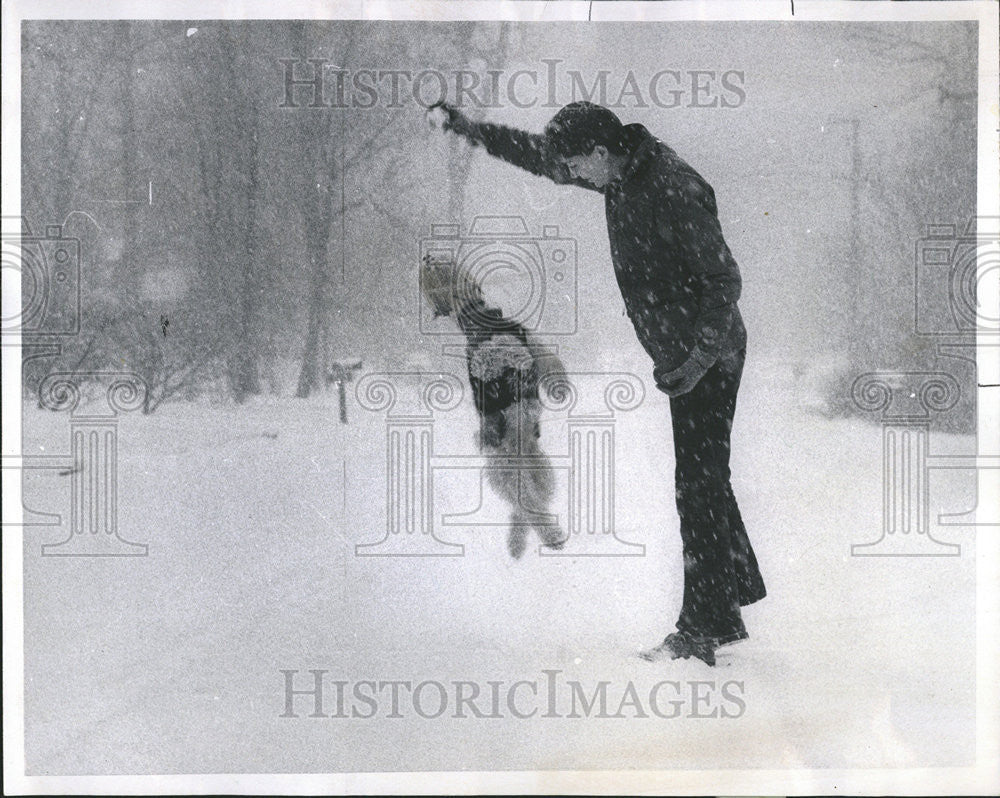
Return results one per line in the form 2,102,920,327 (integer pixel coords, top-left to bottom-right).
2,0,1000,795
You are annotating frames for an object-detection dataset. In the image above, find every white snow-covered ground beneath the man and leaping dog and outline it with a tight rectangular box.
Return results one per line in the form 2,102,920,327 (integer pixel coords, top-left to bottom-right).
24,361,975,775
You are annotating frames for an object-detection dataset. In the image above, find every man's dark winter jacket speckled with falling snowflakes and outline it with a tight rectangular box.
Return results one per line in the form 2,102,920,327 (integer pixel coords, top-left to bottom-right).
467,123,746,371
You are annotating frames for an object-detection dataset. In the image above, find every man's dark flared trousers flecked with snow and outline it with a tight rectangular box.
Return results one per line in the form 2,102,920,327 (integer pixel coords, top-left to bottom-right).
670,350,766,645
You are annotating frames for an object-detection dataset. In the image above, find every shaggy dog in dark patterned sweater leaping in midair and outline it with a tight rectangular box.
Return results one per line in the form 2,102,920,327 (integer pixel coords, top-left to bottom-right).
420,258,565,559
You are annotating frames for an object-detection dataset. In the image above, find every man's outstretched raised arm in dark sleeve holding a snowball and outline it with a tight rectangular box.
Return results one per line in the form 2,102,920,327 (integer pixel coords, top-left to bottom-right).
428,103,596,190
